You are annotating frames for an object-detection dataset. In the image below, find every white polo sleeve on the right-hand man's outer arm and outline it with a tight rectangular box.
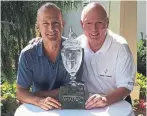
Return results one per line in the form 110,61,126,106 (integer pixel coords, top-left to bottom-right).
116,44,136,90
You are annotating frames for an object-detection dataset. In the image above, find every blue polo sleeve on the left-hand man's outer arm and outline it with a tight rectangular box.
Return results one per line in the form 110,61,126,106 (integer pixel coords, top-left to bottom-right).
17,52,33,89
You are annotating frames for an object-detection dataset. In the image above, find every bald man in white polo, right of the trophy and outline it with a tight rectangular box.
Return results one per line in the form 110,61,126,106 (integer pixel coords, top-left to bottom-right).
78,2,136,109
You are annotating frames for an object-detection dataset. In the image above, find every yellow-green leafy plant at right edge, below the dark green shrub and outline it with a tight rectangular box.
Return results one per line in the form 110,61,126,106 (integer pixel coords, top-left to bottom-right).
137,73,147,98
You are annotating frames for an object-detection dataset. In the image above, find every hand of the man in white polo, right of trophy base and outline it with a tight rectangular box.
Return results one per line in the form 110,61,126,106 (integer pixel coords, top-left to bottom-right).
85,94,107,109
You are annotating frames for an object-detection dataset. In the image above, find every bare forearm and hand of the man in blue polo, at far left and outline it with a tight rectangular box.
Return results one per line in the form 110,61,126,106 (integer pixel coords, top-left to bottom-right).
16,85,61,110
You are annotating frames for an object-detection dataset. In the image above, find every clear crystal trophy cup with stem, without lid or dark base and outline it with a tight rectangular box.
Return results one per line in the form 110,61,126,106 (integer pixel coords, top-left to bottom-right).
61,46,82,86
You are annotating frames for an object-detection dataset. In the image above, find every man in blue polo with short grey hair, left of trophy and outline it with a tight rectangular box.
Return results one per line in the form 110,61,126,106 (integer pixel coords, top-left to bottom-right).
16,3,82,110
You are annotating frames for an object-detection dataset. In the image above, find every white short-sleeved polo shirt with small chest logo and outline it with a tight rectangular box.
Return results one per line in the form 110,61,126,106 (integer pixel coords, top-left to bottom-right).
77,30,136,95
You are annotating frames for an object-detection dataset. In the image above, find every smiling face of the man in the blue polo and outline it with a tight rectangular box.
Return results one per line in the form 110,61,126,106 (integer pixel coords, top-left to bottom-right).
38,8,63,42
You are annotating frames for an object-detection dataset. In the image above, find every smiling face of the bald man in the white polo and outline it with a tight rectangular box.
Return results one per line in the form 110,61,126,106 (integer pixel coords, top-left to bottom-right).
81,8,108,45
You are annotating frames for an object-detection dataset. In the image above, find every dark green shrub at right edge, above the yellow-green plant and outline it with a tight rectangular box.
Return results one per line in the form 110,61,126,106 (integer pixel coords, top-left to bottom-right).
137,39,147,76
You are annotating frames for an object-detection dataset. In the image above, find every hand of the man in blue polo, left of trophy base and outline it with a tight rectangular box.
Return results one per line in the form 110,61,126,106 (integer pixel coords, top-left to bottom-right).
38,97,61,110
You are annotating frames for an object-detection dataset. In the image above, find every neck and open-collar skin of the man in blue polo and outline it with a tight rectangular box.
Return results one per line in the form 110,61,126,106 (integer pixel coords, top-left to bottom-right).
44,42,60,62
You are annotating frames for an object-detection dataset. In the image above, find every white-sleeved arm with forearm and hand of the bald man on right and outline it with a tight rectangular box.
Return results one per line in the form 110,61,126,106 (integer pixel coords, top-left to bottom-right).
86,45,136,109
